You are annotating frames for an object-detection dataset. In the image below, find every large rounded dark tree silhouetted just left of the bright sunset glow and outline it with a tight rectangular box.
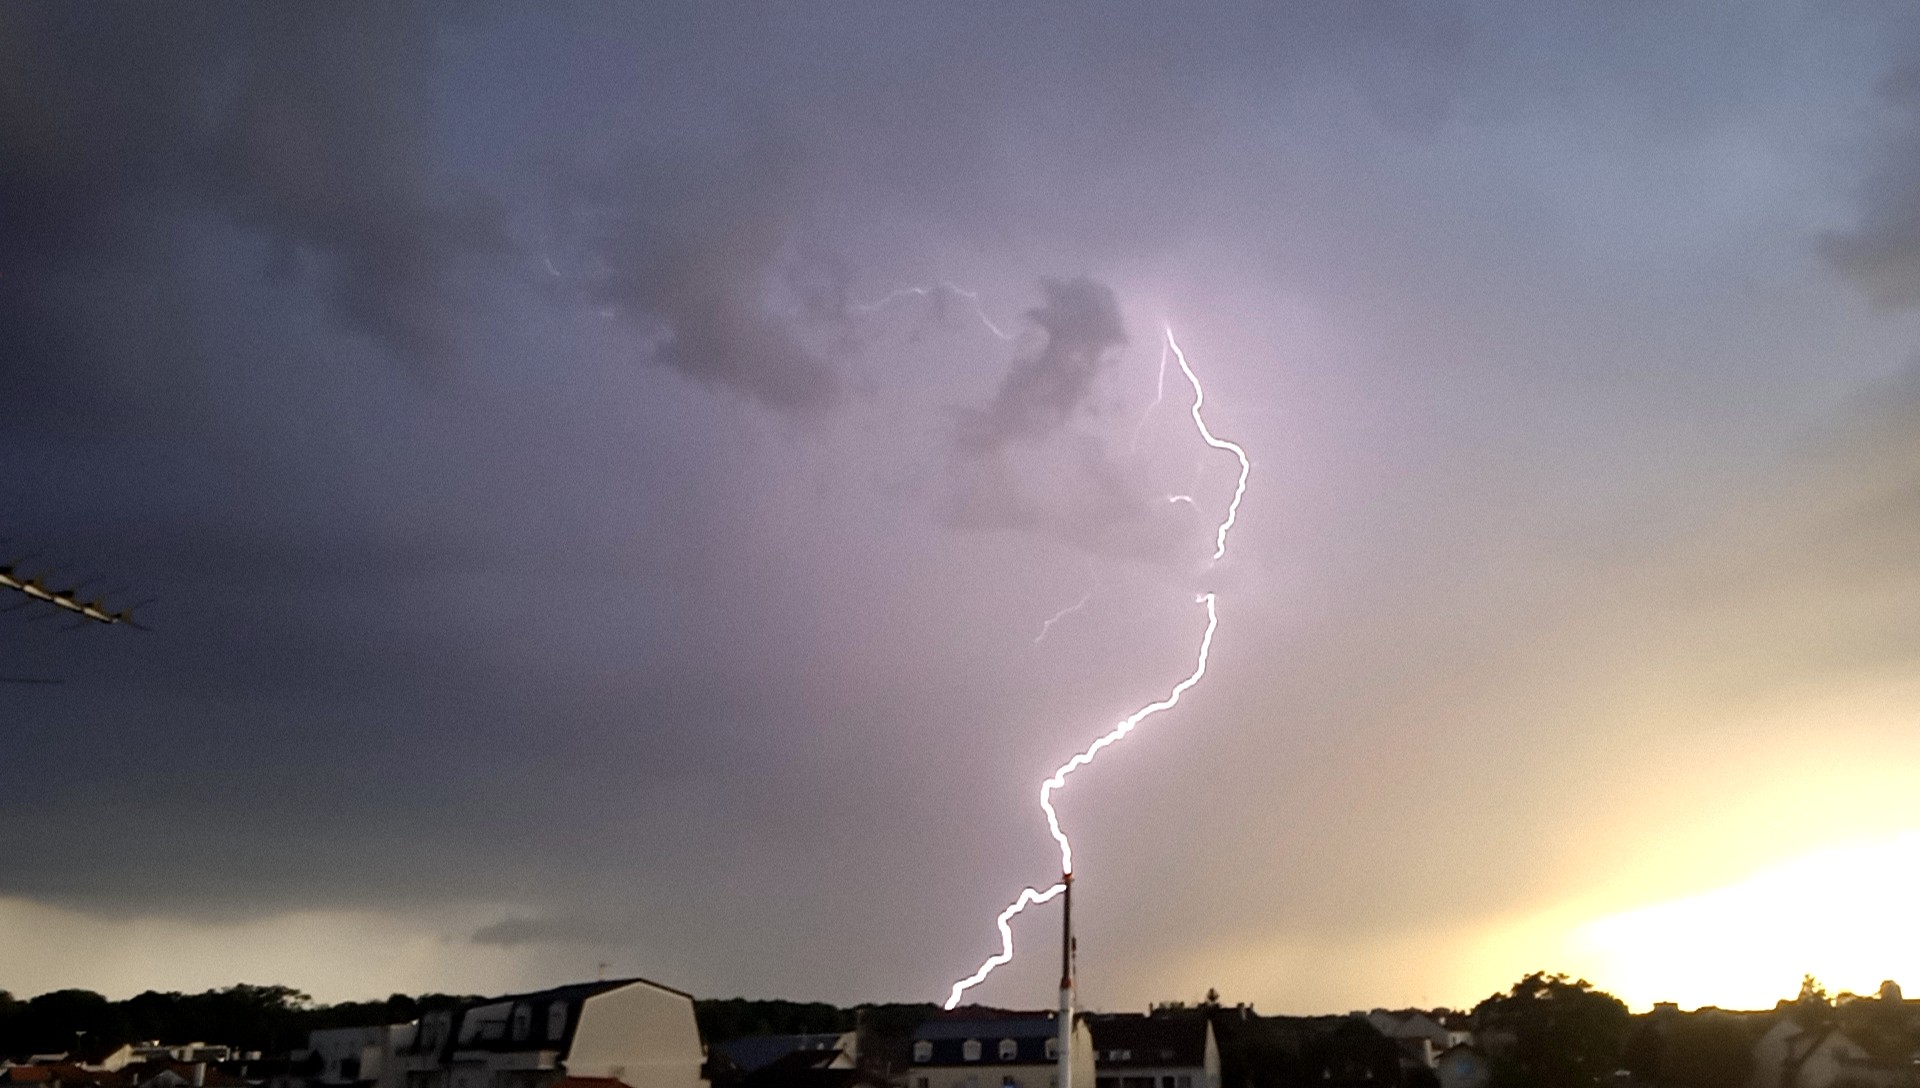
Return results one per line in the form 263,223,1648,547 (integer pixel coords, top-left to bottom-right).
1473,971,1632,1088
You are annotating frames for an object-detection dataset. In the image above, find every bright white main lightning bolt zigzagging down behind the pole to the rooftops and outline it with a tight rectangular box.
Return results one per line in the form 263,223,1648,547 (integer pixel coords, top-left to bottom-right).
945,326,1252,1009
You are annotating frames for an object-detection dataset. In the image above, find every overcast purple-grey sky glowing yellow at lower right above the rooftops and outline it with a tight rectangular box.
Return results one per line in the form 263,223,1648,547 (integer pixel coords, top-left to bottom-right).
0,0,1920,1011
